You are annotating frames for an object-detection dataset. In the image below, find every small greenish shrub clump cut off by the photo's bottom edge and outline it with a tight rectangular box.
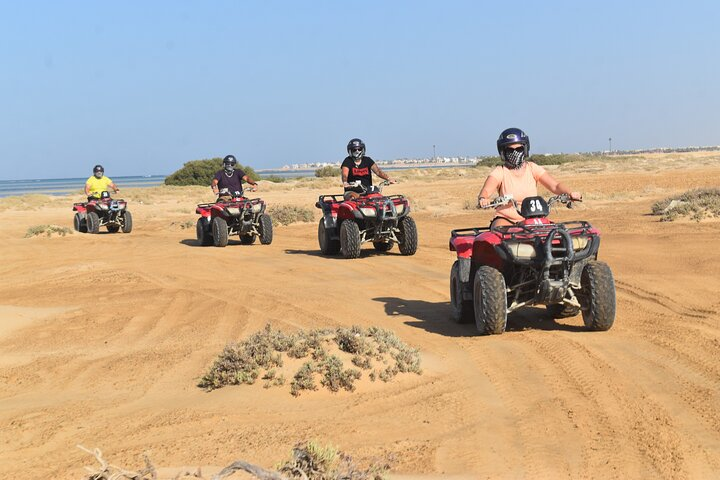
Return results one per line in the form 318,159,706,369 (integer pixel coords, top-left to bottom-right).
277,441,391,480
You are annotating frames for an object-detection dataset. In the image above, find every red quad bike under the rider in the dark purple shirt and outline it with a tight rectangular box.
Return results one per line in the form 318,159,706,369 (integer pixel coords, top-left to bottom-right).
195,188,272,247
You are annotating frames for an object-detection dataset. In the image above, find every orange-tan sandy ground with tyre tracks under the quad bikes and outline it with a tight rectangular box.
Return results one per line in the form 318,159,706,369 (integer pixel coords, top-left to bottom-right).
0,154,720,479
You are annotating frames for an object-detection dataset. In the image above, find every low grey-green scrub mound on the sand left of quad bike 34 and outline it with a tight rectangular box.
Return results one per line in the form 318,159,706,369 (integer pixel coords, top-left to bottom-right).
198,325,422,396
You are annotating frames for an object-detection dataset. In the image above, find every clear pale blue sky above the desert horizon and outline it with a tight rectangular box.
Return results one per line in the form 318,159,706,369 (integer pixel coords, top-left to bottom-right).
0,0,720,179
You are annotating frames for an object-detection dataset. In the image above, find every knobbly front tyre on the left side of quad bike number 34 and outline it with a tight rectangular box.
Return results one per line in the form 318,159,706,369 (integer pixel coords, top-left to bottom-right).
473,265,507,335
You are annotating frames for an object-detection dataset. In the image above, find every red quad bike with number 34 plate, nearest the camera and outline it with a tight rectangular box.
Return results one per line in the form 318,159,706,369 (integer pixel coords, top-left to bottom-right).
450,194,615,334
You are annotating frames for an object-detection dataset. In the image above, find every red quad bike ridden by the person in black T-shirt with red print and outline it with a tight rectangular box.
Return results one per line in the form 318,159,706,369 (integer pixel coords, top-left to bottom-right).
315,181,418,258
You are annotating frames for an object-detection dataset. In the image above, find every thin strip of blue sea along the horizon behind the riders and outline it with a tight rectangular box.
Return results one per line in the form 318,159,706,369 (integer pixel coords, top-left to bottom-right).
0,164,478,198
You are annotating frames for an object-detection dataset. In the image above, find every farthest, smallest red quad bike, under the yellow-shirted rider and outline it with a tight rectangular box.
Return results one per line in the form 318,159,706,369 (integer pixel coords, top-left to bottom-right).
73,192,132,233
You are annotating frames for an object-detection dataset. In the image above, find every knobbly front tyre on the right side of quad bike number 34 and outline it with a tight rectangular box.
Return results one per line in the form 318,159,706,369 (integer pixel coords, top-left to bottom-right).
578,261,615,331
